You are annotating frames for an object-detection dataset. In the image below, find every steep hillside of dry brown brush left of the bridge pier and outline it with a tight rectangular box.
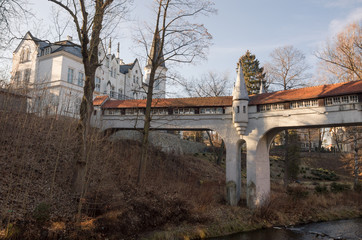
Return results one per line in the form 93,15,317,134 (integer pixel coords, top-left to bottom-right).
0,111,225,239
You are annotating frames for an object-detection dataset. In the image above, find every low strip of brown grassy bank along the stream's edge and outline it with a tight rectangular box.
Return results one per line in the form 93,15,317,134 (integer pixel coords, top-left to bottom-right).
141,188,362,240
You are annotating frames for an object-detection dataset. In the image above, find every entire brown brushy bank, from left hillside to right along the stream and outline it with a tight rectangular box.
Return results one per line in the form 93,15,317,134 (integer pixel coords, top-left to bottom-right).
0,112,362,239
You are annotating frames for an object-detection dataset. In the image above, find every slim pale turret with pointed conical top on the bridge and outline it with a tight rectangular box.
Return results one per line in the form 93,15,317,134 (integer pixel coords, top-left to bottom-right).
233,61,249,135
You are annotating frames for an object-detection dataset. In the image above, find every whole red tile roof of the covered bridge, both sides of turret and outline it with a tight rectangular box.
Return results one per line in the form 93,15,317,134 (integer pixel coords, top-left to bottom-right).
93,80,362,108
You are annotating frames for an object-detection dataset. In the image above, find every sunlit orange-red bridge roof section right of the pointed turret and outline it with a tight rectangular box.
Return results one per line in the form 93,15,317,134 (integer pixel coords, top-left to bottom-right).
249,80,362,105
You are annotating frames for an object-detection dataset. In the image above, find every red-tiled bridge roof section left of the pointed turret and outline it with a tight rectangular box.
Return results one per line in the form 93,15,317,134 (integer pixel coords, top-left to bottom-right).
103,96,232,108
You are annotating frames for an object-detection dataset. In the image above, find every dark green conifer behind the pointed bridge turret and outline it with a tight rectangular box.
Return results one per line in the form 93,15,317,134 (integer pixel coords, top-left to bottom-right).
240,50,267,95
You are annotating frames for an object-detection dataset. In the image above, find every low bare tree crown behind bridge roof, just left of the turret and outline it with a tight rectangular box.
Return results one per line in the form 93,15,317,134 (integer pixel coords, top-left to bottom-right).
182,71,232,97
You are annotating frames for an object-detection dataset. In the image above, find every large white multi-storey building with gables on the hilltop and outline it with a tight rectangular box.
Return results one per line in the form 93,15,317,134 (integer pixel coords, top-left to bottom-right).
11,32,166,117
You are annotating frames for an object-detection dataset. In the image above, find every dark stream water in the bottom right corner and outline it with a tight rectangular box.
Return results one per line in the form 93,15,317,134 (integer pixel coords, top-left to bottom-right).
210,218,362,240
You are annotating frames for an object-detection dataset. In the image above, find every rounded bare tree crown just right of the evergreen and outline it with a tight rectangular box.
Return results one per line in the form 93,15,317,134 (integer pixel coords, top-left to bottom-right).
264,46,310,90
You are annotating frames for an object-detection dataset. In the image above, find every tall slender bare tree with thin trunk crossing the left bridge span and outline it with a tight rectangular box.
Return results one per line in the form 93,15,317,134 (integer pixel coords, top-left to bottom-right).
137,0,215,184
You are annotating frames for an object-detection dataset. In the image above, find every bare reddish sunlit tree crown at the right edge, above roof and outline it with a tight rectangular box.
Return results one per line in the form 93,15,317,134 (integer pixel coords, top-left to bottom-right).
315,22,362,82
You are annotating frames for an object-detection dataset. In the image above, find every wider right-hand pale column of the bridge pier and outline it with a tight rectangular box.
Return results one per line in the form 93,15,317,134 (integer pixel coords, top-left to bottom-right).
245,135,270,208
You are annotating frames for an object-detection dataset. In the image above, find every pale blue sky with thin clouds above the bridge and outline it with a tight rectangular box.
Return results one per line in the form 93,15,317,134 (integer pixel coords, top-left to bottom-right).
16,0,362,95
